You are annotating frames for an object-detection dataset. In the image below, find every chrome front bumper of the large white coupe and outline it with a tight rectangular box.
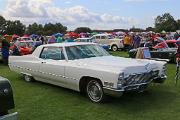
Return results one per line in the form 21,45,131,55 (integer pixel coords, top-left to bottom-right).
103,76,167,97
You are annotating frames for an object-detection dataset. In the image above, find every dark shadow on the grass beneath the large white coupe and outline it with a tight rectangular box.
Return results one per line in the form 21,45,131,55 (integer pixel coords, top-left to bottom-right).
27,78,177,112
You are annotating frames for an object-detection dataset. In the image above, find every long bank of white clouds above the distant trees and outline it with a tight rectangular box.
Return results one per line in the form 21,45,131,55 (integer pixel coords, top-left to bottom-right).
2,0,145,29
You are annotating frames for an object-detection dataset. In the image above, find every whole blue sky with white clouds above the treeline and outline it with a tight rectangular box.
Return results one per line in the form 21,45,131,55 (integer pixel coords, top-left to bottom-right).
0,0,180,30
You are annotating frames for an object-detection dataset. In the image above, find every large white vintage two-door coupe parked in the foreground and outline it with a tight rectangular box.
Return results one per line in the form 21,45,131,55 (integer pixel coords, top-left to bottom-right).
9,42,166,102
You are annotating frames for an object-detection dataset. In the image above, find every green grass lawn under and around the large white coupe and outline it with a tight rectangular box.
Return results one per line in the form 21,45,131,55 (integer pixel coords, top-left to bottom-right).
0,52,180,120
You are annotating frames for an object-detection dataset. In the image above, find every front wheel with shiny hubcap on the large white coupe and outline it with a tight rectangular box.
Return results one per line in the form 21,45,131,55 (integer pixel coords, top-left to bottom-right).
86,80,105,103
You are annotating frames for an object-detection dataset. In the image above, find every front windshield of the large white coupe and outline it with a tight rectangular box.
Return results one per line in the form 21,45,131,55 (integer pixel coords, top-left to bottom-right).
65,45,110,60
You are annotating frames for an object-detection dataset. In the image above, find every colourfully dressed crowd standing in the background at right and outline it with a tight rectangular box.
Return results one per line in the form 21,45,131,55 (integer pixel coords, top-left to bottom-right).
121,31,180,50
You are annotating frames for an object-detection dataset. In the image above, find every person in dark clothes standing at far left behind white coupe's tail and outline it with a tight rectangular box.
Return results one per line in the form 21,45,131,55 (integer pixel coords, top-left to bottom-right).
2,39,10,65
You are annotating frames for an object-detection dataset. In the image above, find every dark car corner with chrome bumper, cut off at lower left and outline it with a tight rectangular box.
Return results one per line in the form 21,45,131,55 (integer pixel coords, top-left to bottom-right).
0,76,17,120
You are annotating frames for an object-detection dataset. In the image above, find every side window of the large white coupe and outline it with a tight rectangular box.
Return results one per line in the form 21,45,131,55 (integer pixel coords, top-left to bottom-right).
40,47,65,60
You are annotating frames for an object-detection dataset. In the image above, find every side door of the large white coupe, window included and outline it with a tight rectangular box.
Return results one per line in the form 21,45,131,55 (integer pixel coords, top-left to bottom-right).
39,47,67,86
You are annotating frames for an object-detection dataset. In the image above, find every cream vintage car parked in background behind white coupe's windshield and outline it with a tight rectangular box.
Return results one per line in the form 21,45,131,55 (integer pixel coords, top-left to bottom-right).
93,34,124,51
